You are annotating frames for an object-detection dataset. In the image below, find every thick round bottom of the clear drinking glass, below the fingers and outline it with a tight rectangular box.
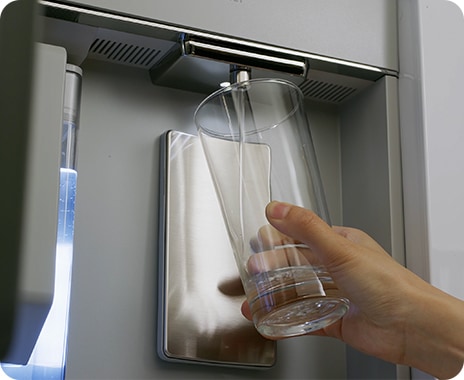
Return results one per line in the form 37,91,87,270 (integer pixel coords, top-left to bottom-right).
256,297,349,339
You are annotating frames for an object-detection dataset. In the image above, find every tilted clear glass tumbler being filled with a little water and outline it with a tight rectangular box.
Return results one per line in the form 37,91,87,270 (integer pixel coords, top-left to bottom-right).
194,79,349,339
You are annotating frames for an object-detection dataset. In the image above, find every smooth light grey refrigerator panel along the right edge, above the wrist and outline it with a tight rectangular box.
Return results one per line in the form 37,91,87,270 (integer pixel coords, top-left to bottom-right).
398,0,464,379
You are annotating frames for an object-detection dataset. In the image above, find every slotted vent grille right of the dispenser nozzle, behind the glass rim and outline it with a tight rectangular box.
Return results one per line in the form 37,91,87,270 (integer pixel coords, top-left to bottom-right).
300,79,356,103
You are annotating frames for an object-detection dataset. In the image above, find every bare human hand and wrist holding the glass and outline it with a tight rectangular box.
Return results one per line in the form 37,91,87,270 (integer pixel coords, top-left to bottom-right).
242,202,464,377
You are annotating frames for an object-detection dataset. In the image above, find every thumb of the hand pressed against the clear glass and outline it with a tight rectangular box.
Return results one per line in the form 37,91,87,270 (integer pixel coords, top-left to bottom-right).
266,201,353,272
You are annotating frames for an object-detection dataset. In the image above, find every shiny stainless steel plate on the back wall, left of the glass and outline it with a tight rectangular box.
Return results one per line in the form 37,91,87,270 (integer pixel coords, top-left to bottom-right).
158,131,275,367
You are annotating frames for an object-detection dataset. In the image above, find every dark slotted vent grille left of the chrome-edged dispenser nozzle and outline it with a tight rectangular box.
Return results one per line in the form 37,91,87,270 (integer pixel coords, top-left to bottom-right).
89,38,161,68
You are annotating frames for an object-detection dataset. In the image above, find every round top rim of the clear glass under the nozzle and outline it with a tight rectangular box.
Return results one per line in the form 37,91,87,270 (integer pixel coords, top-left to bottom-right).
193,78,304,138
